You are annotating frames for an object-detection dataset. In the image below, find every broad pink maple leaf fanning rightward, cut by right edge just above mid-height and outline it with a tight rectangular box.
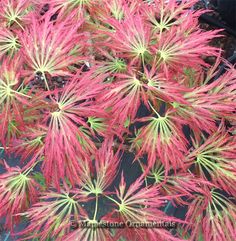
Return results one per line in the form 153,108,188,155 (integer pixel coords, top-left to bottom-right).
171,64,236,135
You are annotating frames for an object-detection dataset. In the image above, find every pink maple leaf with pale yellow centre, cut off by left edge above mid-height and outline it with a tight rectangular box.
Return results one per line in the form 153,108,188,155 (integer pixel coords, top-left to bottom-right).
0,57,31,144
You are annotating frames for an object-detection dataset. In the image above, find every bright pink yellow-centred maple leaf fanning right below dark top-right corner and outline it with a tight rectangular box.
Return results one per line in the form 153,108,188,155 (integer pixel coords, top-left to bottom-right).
151,22,219,77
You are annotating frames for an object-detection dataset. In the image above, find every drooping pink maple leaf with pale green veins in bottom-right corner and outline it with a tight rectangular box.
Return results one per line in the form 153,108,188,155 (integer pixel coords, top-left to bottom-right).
185,186,236,241
